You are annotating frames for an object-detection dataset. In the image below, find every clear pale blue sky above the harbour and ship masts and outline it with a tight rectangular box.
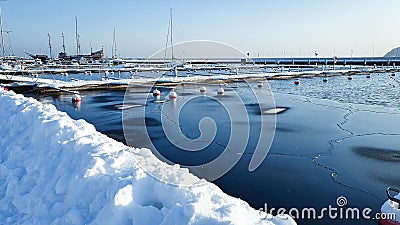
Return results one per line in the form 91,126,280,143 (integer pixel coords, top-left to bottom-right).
0,0,400,57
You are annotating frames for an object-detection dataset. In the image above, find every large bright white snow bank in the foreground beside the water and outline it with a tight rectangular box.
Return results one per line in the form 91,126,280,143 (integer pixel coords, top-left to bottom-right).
0,90,295,225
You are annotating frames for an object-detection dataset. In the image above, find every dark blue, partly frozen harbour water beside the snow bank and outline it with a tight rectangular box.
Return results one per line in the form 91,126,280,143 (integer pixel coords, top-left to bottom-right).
26,74,400,224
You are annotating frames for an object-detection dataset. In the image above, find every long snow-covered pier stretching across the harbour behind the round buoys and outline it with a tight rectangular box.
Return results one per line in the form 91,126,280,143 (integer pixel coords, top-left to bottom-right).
0,66,390,92
